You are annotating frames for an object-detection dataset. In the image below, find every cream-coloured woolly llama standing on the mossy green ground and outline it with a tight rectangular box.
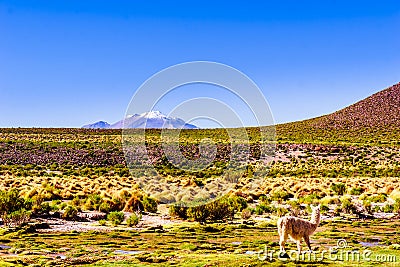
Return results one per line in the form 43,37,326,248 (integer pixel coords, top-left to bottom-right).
278,205,321,254
